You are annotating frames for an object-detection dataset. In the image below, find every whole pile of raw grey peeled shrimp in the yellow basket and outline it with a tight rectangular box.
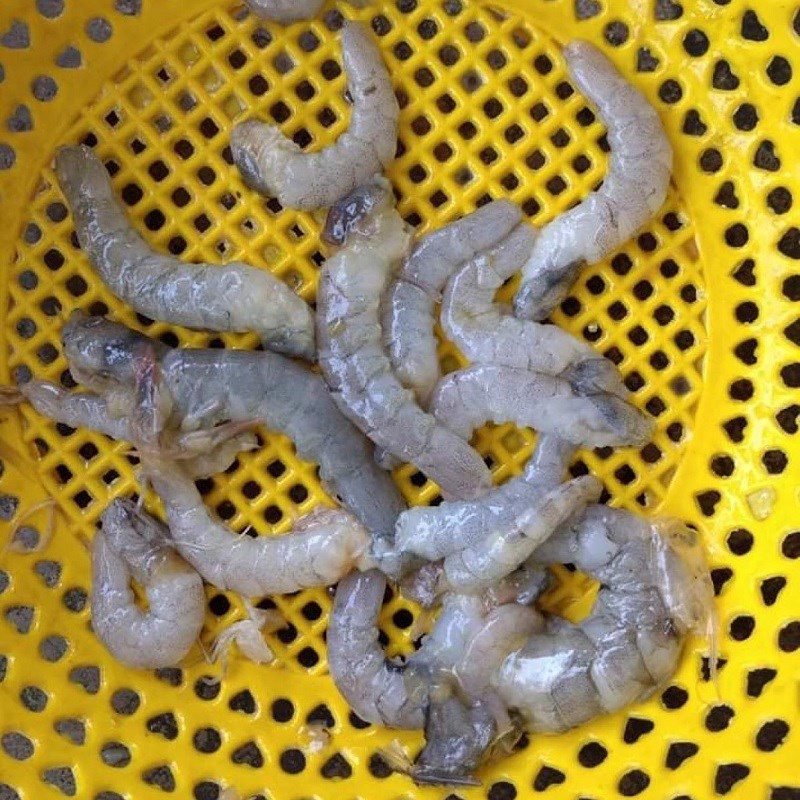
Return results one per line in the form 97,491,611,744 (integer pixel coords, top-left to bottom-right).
3,7,714,784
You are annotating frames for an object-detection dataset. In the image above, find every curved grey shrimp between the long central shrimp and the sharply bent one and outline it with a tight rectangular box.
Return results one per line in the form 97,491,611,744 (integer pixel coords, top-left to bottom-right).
381,200,520,407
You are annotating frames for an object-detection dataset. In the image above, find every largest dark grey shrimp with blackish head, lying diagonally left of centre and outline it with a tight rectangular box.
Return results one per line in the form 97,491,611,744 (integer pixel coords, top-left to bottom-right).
62,313,405,572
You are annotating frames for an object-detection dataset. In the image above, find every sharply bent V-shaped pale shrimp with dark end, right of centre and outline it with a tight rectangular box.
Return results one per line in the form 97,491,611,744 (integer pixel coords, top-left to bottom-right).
441,223,628,398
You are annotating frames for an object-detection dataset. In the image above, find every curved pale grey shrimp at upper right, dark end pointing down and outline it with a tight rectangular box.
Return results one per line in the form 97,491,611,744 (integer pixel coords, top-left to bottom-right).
514,41,672,320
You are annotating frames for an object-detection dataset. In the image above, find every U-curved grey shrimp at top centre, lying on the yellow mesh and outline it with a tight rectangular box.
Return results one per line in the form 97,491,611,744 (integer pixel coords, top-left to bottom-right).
231,21,400,209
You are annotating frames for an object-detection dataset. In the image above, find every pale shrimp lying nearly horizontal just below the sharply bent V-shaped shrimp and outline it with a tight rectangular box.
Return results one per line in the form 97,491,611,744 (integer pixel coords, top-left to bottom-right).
431,364,653,447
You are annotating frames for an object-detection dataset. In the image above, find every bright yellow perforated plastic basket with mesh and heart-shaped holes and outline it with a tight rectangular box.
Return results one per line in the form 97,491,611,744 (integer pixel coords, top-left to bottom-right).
0,0,800,800
